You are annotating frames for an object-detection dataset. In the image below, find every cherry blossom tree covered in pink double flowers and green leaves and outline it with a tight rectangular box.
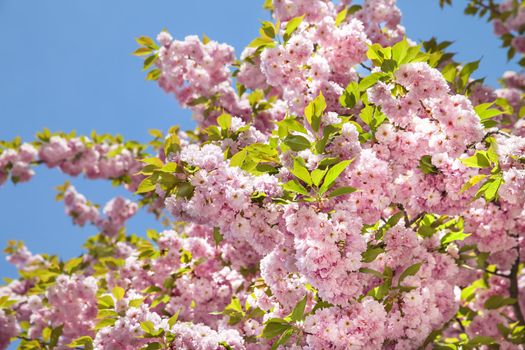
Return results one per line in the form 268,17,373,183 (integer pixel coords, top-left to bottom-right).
0,0,525,350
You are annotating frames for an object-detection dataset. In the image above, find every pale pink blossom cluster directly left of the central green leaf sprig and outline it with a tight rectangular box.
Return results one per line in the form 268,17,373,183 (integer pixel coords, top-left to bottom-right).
166,144,283,253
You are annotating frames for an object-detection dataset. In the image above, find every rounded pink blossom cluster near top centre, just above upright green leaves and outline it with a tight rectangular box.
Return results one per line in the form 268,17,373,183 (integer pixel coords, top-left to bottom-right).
261,17,369,113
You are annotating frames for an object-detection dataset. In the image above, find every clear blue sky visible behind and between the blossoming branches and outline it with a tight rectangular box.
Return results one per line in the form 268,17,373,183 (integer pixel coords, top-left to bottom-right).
0,0,516,277
